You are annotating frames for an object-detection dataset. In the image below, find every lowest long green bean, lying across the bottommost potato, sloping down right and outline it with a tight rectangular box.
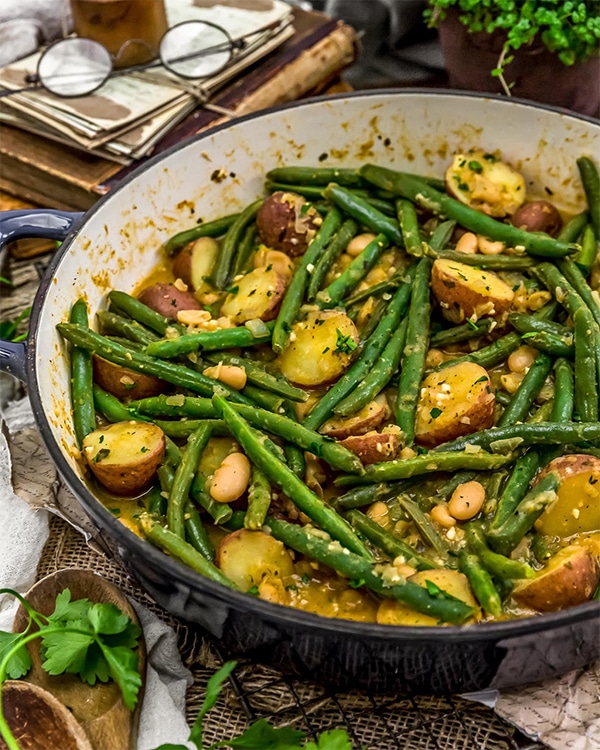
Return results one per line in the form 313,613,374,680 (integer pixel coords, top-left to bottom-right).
250,518,473,623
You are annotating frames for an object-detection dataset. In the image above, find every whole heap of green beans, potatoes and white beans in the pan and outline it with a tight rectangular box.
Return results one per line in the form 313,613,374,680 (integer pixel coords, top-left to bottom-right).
58,149,600,625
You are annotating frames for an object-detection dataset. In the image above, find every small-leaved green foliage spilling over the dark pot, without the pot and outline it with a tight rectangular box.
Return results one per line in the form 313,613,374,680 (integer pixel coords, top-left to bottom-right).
425,0,600,93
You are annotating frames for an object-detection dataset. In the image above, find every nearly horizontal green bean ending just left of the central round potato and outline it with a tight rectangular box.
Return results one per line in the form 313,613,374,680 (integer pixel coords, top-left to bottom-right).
146,322,275,359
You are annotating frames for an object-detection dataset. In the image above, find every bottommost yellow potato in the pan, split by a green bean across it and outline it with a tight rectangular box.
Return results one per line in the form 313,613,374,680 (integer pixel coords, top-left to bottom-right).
377,568,479,625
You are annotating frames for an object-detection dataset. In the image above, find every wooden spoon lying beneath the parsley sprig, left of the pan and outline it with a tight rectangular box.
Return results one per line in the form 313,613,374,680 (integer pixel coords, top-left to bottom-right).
13,568,146,750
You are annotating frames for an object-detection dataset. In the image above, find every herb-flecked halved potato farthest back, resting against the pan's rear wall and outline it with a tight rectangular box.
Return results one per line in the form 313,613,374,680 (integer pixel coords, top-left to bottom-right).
446,149,526,217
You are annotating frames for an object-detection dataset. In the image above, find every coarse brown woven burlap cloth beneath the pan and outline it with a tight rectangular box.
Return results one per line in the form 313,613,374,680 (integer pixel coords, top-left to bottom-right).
0,250,543,750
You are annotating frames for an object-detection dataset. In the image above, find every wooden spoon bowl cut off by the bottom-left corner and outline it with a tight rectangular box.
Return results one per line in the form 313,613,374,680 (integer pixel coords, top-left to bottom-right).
0,680,92,750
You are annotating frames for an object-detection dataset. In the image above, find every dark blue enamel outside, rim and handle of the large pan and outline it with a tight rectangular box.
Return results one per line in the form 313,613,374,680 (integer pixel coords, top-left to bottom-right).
0,90,600,693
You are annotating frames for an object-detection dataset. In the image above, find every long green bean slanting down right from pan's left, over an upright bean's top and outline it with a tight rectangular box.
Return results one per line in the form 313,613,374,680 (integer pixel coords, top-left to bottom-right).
57,323,252,405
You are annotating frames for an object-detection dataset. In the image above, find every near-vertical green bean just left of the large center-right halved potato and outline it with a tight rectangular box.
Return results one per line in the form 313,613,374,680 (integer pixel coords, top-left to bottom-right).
396,258,433,446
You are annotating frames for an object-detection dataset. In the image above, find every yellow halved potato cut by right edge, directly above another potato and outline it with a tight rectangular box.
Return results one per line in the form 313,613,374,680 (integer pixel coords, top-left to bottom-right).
535,453,600,539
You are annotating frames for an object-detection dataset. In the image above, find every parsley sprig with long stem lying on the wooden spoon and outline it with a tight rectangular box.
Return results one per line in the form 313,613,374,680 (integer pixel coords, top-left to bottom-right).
0,589,142,750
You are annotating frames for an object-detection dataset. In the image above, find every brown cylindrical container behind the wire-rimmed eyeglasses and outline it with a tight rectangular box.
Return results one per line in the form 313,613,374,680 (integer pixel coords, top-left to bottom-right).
71,0,168,68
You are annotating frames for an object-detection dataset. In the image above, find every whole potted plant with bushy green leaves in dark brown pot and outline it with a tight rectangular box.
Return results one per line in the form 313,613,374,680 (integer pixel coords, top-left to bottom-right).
425,0,600,116
